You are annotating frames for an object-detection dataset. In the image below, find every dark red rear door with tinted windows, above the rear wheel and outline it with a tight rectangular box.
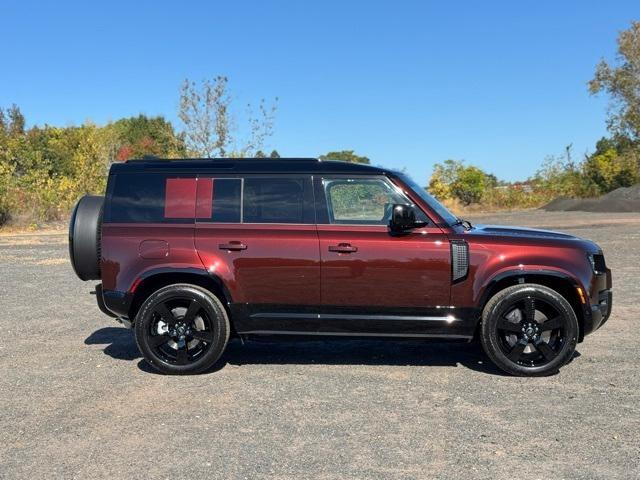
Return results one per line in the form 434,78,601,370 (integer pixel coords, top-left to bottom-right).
196,175,320,333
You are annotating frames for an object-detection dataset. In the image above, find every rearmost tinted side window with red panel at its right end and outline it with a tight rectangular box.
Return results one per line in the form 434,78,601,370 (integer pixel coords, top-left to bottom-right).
104,173,196,223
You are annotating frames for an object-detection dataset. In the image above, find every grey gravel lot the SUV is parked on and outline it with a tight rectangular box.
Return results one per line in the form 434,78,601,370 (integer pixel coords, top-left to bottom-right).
0,211,640,479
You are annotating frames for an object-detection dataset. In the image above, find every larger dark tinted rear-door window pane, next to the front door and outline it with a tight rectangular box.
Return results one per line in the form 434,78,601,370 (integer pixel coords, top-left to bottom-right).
242,177,314,223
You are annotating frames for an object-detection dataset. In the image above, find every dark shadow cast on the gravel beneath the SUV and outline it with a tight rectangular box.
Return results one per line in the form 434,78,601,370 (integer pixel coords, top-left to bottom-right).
84,327,528,376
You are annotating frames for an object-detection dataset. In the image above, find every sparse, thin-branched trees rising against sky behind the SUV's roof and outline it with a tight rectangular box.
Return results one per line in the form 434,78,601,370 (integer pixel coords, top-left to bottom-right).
178,76,277,157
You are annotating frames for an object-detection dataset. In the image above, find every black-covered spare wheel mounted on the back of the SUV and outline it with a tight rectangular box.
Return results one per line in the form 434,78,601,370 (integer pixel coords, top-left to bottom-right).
69,195,104,280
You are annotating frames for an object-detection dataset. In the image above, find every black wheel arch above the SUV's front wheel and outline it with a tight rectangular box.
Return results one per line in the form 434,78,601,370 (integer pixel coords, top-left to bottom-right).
479,270,585,342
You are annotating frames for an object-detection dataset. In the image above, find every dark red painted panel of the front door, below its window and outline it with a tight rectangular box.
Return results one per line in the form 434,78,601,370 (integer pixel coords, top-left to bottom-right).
318,225,451,307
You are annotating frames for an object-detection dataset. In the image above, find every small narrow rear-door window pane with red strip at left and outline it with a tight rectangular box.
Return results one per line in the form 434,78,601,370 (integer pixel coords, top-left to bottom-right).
196,177,242,223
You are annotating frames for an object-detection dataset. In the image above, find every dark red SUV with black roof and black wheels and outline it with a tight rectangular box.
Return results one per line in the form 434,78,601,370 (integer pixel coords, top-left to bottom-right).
69,159,611,375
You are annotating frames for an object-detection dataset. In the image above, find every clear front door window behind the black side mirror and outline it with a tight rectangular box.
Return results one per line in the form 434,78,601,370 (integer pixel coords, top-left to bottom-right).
322,178,418,225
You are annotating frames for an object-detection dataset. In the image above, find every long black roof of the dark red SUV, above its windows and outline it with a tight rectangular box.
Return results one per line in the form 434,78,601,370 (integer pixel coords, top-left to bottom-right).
111,158,389,175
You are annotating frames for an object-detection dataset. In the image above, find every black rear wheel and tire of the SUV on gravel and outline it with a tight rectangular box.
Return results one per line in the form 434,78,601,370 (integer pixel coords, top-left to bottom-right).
135,284,230,375
